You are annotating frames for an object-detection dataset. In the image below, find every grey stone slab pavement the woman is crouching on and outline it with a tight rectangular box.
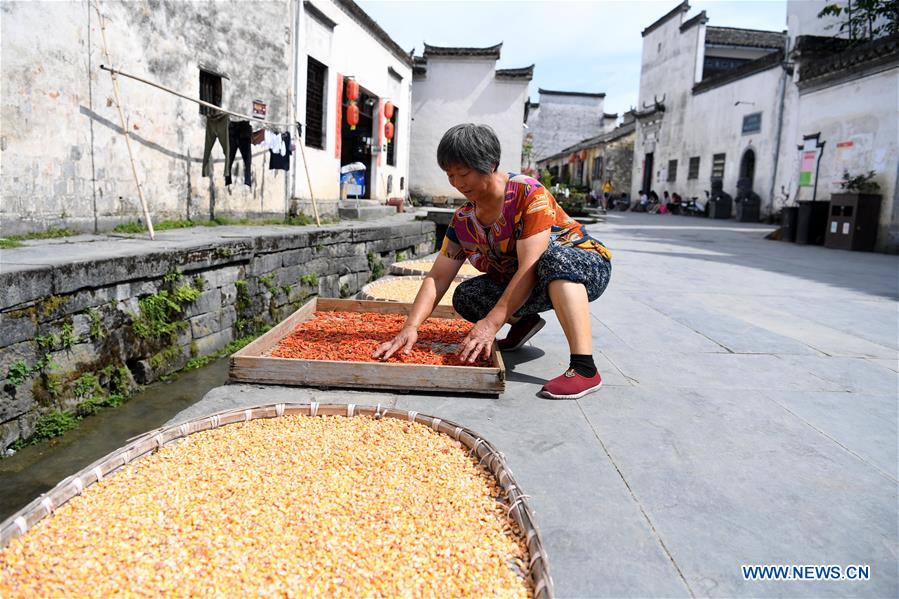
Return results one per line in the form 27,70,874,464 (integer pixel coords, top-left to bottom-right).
173,213,899,597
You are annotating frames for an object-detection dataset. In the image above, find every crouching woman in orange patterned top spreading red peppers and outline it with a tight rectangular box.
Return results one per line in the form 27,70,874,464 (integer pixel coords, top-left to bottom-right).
372,123,612,399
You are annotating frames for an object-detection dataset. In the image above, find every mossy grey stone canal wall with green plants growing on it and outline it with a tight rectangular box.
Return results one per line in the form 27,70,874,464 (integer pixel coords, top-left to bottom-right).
0,221,434,453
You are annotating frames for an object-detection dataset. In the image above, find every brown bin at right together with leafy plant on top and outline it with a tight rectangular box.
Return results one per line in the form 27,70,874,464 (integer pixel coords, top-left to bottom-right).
824,171,882,252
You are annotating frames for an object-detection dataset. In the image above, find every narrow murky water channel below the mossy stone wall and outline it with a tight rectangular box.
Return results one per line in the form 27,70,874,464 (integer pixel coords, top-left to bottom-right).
0,357,228,521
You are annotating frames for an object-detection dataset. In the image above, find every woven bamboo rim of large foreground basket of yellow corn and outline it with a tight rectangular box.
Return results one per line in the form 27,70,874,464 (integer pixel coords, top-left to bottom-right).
0,402,554,599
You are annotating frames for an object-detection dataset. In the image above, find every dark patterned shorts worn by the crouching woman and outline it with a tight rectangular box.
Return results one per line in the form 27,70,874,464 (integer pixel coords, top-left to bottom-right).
453,244,612,322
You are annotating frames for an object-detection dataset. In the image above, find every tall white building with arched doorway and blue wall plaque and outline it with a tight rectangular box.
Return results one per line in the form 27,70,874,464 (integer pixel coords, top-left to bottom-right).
631,2,788,206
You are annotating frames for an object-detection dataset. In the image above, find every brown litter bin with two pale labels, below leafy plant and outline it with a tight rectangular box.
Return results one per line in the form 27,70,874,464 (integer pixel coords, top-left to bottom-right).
824,193,881,252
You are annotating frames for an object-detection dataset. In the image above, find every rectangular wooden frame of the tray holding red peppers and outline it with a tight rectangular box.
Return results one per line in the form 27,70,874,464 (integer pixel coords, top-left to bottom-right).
230,297,506,395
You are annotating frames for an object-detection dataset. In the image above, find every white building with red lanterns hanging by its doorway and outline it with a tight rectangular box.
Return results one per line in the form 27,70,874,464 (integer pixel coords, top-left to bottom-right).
293,0,412,213
